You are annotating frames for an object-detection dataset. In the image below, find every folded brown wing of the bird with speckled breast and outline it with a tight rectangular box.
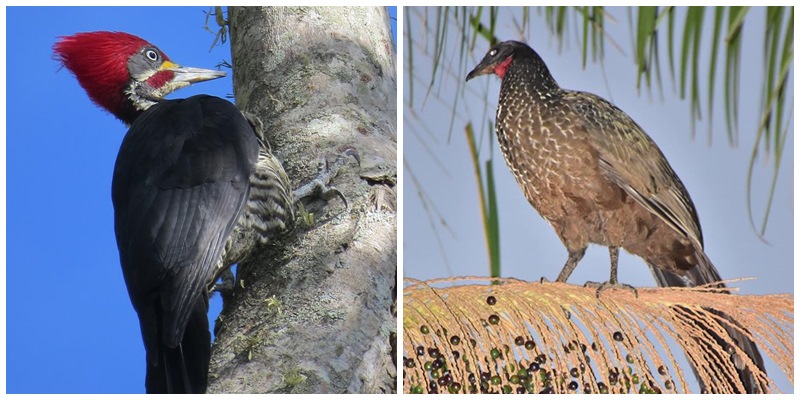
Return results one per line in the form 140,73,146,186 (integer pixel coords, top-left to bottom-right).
565,92,703,248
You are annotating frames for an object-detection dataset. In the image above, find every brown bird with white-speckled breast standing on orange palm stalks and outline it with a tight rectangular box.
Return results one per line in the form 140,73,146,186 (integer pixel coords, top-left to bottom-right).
467,41,766,393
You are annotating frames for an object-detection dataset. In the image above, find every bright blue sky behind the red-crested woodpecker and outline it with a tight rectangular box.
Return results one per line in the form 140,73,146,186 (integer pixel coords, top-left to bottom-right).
6,7,396,393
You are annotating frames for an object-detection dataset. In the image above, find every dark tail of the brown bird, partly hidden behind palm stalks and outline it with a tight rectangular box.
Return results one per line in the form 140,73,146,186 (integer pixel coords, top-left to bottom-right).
648,250,767,393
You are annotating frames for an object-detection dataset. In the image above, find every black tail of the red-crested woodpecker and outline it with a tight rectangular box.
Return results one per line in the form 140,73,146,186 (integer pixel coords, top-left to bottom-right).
145,296,211,393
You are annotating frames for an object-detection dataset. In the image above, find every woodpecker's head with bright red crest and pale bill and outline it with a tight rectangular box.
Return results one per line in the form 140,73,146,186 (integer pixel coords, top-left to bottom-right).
53,32,225,124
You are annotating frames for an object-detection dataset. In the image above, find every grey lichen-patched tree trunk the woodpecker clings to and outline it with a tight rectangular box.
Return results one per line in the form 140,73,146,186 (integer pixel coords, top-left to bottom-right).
209,7,397,393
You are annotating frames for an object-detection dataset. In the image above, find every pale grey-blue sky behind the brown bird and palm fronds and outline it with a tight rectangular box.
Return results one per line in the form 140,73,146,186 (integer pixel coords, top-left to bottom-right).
403,7,795,392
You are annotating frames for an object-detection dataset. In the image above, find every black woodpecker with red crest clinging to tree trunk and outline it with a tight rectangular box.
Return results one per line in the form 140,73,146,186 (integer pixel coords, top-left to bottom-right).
53,32,296,393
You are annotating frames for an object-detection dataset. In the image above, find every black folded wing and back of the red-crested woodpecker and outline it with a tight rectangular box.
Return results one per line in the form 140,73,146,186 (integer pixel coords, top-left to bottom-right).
112,96,258,349
